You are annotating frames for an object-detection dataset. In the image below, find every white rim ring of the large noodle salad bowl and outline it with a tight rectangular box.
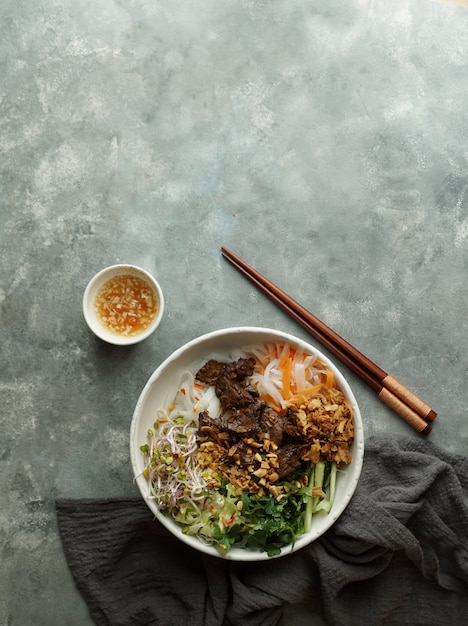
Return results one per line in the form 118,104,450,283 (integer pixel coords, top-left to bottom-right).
130,326,364,561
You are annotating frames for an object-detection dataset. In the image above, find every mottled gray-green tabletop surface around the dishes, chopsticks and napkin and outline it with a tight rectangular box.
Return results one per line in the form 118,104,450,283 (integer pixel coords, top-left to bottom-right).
0,0,468,626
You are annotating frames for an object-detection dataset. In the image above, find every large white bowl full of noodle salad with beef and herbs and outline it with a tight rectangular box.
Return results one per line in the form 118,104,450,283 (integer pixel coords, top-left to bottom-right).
130,327,364,561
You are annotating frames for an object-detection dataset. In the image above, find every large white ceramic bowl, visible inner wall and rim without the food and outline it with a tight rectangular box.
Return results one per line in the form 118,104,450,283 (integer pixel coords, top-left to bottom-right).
130,327,364,561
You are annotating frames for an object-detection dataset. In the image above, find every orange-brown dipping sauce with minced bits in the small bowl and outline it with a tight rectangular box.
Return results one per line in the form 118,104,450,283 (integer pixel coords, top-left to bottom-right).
94,274,158,336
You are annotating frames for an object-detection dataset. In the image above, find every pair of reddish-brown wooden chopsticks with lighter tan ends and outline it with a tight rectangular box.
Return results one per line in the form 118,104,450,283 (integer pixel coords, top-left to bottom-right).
222,247,437,434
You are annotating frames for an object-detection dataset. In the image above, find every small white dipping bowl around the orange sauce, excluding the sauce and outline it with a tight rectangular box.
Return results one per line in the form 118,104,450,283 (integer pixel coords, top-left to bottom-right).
83,264,164,346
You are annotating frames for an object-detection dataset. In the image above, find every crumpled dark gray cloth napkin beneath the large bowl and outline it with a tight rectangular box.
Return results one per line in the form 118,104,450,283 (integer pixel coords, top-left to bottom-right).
56,436,468,626
